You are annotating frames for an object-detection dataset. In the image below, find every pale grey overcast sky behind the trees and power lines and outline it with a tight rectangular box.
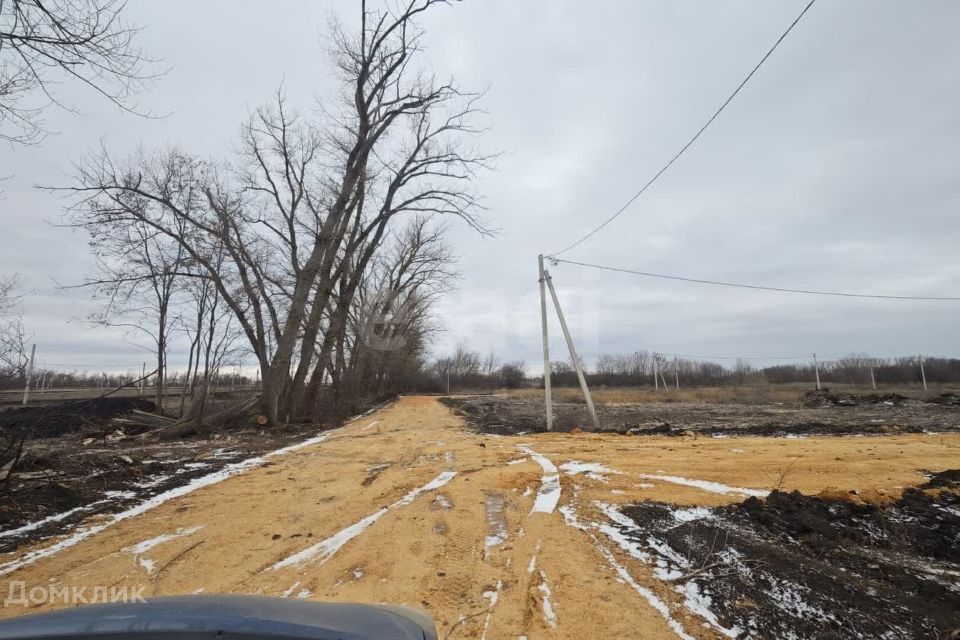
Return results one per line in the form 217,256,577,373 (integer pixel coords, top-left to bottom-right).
0,0,960,371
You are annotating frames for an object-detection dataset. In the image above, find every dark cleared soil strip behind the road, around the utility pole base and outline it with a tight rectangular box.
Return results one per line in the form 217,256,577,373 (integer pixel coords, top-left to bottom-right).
441,395,960,436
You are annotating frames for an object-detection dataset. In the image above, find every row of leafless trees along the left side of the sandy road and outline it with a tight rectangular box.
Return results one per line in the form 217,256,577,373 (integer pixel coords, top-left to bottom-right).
41,0,493,424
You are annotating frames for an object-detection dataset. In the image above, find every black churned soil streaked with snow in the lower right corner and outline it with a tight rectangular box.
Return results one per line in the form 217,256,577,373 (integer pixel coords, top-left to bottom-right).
620,488,960,639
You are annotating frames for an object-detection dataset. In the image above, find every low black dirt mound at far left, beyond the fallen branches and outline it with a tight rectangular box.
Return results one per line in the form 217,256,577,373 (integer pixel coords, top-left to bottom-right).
0,398,156,439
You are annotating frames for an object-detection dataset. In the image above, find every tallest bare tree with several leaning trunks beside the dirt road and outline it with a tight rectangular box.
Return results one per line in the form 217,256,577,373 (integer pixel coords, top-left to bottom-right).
63,0,492,424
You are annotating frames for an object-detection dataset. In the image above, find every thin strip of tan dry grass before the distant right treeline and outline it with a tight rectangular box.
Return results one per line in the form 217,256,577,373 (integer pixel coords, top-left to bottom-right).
502,384,948,404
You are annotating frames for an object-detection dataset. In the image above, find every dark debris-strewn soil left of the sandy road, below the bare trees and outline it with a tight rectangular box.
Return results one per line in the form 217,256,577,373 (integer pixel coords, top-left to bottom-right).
0,398,386,552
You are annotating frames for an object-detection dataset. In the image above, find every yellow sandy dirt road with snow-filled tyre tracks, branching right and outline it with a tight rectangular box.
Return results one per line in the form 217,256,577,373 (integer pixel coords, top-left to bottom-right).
0,397,960,638
